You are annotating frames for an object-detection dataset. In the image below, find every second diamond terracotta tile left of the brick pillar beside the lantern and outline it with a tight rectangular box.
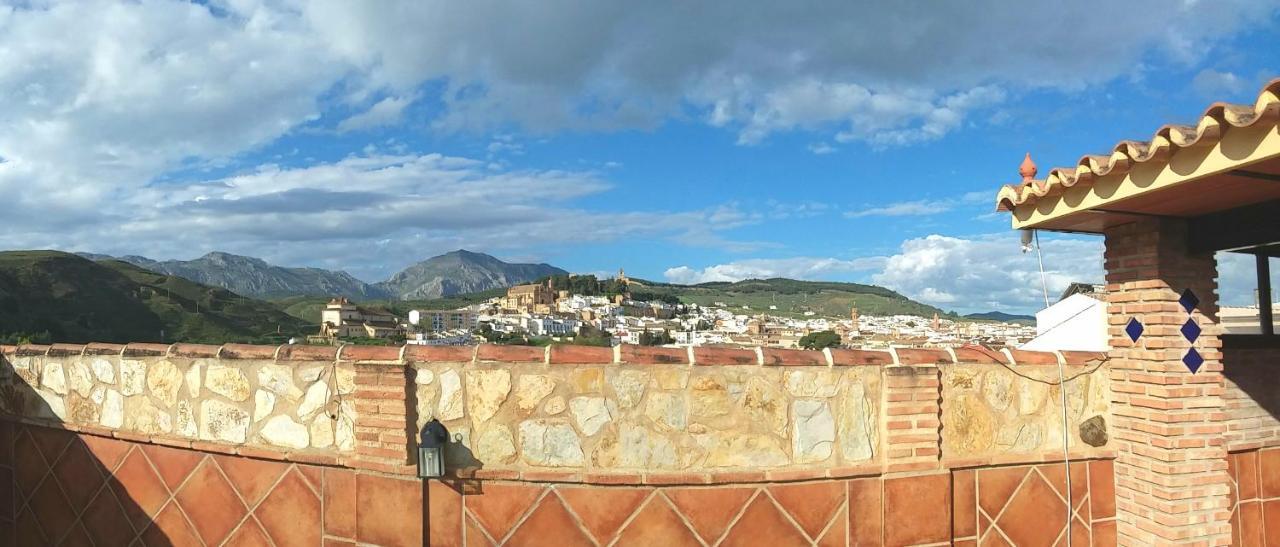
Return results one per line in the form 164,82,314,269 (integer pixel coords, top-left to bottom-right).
175,461,248,546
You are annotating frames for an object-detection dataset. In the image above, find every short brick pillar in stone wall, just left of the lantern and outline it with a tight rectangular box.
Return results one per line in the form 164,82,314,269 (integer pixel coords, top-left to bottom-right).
342,347,417,475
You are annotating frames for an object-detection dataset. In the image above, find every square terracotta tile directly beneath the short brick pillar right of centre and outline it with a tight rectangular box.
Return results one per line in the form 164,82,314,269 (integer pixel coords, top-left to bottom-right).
884,473,957,546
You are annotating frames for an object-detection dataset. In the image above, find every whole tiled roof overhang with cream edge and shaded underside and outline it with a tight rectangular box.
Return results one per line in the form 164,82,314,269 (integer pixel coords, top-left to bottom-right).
997,79,1280,233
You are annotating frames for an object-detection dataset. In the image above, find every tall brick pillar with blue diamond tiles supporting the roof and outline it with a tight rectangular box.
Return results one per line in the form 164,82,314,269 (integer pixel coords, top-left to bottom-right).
1106,219,1231,546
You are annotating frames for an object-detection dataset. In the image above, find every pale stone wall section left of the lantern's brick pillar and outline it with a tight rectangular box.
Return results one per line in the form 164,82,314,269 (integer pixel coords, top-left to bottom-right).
0,345,355,455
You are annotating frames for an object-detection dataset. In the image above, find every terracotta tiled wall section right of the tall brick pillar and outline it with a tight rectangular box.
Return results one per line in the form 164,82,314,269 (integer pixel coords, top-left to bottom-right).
1226,448,1280,546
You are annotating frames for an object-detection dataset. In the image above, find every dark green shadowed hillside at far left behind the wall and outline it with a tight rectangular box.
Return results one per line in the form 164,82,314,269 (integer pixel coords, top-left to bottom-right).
0,251,314,343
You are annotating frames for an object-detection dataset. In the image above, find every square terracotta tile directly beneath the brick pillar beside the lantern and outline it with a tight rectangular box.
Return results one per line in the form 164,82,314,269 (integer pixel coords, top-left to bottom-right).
356,474,422,547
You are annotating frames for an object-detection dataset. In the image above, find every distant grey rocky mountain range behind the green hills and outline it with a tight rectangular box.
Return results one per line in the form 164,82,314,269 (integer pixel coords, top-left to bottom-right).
81,250,567,300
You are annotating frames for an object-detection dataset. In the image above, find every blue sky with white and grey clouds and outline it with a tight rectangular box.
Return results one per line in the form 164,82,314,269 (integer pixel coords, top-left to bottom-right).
0,0,1280,313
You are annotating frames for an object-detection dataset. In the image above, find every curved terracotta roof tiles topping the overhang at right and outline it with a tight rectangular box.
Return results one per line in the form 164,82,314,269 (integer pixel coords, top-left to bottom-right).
996,78,1280,211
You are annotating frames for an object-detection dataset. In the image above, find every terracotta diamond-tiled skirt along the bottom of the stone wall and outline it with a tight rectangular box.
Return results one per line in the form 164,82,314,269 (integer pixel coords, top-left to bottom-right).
0,421,1126,547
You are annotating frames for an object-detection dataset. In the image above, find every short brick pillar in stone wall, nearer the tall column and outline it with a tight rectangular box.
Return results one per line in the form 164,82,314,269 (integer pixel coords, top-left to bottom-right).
882,365,942,473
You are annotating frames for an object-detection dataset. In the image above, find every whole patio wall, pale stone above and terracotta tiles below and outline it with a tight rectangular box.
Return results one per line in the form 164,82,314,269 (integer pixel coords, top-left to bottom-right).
0,345,1115,544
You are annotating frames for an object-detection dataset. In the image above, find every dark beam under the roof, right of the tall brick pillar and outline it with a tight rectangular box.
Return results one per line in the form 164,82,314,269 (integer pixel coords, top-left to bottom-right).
1187,200,1280,252
